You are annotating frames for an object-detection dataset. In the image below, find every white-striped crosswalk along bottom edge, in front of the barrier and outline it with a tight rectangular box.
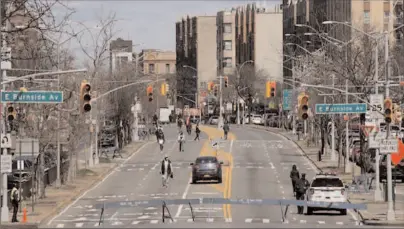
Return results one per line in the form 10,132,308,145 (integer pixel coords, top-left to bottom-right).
52,218,362,228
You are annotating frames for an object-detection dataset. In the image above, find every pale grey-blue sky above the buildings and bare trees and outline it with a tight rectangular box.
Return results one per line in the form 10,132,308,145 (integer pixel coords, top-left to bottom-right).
54,0,280,65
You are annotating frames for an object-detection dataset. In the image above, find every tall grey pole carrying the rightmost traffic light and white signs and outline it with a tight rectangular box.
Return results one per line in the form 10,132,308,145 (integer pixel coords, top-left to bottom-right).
384,33,396,221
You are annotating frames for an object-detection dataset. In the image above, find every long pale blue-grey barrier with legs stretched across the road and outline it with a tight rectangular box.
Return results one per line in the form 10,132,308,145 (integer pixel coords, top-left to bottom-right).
95,198,367,225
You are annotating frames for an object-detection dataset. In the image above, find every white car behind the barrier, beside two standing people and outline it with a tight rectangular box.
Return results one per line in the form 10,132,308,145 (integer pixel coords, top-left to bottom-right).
307,173,347,215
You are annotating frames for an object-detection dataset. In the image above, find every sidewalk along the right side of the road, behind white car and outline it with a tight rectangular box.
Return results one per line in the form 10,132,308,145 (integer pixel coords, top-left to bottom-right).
251,125,404,226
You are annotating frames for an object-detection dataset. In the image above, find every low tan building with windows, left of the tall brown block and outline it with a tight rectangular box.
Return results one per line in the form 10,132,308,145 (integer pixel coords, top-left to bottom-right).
137,49,176,75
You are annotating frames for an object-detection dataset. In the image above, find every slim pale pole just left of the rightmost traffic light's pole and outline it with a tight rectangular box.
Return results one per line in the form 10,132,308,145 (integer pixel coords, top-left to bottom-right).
374,41,383,201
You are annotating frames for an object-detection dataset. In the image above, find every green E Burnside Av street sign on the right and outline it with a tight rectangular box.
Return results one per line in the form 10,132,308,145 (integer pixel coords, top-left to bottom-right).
316,103,367,114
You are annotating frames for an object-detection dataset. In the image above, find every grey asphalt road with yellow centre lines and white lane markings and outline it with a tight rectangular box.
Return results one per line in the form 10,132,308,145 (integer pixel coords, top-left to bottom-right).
42,126,370,228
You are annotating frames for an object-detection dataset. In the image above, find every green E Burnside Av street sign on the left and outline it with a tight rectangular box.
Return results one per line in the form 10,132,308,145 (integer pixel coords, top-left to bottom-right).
1,91,63,103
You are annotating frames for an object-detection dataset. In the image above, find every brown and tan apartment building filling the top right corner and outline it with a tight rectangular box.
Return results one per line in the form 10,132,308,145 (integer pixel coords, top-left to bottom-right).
282,0,403,81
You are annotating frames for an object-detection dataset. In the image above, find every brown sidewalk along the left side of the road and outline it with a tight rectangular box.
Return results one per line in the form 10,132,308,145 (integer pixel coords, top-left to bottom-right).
2,141,148,228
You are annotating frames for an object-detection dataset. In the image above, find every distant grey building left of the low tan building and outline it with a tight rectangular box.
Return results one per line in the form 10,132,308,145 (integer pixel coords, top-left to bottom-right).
109,38,134,74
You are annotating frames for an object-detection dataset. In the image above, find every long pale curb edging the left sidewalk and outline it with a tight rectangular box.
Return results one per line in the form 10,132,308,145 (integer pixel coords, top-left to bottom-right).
36,142,147,225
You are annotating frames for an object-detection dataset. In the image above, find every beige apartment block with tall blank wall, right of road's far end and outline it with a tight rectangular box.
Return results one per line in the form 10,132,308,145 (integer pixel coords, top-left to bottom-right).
235,4,283,86
